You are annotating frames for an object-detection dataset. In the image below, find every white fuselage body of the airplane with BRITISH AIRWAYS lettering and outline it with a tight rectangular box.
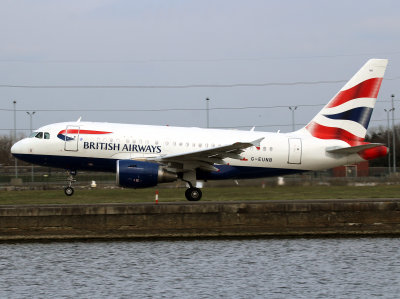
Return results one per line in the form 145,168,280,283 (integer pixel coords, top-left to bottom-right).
12,122,363,177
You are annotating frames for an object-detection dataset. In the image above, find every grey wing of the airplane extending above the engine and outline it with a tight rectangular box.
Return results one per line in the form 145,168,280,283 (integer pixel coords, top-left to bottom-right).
148,138,264,172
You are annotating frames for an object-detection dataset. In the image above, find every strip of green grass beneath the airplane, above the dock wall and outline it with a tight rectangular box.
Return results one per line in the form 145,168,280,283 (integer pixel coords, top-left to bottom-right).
0,185,400,205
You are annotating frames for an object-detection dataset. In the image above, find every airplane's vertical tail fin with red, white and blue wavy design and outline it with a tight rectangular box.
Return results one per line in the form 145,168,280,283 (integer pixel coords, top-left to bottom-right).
305,59,388,146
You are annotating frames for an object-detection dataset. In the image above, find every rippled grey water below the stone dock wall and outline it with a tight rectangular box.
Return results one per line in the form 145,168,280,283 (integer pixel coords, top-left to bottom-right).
0,238,400,298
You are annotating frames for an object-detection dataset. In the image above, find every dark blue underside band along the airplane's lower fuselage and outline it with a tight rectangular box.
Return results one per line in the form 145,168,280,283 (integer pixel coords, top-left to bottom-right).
14,154,307,180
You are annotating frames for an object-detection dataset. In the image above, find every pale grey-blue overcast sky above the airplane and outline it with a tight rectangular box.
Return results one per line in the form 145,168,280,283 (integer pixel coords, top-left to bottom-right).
0,0,400,134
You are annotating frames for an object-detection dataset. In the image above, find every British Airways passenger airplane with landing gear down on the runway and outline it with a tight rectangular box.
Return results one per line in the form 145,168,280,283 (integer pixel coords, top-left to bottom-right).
11,59,388,201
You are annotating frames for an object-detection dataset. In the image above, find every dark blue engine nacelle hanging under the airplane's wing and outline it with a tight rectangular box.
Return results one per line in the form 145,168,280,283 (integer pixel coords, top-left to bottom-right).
117,160,178,188
